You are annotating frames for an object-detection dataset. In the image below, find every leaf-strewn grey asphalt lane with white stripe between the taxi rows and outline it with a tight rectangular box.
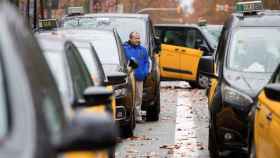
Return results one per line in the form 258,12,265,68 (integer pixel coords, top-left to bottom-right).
116,82,209,158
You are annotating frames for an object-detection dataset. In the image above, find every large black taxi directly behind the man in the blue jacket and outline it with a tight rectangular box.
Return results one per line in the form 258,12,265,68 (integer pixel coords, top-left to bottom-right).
61,10,160,121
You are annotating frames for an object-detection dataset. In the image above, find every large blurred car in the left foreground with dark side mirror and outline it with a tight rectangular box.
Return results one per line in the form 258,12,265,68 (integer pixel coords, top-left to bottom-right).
0,1,116,158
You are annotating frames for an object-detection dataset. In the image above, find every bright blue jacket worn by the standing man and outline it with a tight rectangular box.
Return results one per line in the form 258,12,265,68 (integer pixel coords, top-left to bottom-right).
123,42,149,81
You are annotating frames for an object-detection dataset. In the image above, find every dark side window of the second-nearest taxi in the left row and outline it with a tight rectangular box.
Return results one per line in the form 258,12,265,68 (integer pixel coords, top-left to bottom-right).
67,47,93,99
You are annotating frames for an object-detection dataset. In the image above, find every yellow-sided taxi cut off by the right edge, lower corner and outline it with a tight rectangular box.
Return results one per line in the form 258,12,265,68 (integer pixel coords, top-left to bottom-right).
249,65,280,158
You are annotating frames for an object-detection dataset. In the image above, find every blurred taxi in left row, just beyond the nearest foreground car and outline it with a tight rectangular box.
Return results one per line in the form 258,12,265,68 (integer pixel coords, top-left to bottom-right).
37,34,117,158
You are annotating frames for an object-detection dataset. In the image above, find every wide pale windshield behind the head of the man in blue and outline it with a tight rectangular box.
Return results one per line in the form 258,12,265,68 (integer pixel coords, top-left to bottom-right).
63,17,147,45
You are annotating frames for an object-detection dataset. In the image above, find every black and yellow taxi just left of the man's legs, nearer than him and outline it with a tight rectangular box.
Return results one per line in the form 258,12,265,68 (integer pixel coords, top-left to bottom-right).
49,29,138,137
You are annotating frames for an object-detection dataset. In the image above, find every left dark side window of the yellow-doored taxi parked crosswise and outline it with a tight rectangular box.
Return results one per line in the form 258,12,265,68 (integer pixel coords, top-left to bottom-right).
163,29,186,47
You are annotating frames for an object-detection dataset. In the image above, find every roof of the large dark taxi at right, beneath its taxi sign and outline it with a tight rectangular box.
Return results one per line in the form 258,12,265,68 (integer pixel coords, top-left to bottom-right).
232,11,280,27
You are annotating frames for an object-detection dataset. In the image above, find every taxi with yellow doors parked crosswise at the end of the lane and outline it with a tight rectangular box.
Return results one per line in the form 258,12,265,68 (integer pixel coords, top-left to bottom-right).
154,24,217,88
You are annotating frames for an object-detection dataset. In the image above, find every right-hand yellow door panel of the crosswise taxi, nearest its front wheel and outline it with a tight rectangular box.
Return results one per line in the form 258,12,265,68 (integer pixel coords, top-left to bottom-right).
180,48,203,81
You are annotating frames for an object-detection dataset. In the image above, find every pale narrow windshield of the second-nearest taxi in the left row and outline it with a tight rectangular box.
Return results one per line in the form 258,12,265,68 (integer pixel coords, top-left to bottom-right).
44,50,70,98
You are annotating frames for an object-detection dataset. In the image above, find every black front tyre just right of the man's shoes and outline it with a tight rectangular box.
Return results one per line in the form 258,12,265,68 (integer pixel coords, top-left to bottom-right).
146,89,160,121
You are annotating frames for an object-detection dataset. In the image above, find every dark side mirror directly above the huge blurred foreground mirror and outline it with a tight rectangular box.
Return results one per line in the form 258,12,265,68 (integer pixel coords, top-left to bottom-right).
73,86,113,108
